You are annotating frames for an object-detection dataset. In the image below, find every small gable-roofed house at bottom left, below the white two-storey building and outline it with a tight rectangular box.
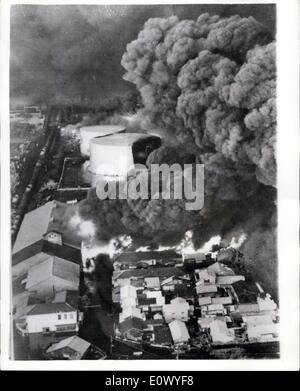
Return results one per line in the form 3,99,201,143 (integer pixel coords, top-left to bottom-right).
46,335,91,360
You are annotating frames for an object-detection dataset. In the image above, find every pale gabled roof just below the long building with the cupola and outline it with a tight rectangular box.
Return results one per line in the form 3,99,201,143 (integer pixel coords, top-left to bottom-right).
26,256,79,289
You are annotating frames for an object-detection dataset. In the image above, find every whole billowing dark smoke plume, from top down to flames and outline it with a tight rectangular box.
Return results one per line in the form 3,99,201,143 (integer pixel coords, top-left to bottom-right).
78,14,276,292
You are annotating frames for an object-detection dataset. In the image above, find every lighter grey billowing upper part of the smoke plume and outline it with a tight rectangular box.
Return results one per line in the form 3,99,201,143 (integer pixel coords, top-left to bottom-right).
122,14,276,188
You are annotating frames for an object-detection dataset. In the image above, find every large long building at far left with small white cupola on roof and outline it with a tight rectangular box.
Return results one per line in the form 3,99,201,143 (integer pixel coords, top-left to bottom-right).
12,201,81,278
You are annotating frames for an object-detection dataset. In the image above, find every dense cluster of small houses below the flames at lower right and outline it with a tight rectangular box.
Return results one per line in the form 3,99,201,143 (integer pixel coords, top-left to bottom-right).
113,250,278,351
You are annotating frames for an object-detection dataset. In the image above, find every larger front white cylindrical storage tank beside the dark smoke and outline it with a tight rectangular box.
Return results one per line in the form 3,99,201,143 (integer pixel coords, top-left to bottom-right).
89,133,161,186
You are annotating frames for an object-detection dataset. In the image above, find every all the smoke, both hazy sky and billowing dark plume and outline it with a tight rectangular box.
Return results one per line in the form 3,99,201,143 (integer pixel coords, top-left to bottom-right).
10,4,276,292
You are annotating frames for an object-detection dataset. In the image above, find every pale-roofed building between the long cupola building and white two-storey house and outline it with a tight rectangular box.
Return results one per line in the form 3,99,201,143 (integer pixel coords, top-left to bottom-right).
24,256,80,298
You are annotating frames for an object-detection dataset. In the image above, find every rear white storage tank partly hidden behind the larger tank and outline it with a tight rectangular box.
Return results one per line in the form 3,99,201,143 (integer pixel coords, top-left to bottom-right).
80,125,126,156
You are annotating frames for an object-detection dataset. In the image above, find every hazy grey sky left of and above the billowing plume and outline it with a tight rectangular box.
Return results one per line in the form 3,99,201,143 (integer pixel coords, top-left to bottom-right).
10,4,275,104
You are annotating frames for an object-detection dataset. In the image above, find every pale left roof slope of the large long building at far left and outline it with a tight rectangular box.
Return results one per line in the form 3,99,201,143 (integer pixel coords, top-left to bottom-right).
13,201,55,254
